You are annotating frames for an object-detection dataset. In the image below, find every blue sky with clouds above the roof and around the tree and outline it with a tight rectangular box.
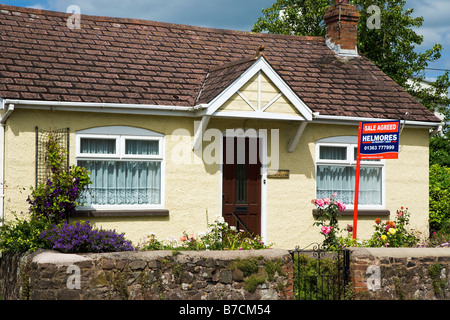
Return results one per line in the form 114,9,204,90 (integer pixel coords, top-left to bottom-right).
0,0,450,80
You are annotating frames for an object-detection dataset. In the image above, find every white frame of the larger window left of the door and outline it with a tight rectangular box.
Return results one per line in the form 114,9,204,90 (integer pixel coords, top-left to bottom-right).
75,126,165,211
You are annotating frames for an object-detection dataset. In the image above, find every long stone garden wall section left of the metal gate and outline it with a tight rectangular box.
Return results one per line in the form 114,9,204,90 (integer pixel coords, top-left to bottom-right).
0,249,293,300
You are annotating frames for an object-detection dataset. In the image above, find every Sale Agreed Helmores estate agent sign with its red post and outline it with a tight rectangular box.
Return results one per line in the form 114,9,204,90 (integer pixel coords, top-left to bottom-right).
353,121,400,239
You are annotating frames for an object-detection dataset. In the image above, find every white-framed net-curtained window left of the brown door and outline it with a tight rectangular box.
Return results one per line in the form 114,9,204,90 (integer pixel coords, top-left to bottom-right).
76,127,164,209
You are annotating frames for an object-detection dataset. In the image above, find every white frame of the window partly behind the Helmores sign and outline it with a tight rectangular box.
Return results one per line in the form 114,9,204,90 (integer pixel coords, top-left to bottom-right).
314,136,386,210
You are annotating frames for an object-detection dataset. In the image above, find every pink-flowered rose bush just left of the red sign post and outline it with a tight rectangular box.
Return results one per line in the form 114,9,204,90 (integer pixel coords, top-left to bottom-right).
311,193,345,250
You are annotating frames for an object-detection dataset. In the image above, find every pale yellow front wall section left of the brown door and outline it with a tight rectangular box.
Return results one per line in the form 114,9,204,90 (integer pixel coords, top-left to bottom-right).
1,110,219,243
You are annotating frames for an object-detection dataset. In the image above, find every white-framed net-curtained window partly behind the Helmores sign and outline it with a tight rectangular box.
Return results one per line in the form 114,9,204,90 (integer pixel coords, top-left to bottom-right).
316,136,384,209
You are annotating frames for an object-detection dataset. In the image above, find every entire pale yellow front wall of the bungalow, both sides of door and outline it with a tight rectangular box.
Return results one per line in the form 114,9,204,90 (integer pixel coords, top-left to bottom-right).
0,109,428,249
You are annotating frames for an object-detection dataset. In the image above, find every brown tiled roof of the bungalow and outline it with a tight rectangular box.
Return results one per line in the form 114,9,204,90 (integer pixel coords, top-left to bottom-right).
0,5,439,122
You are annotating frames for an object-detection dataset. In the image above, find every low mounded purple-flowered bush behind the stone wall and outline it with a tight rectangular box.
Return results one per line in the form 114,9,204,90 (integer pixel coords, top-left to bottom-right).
40,222,134,253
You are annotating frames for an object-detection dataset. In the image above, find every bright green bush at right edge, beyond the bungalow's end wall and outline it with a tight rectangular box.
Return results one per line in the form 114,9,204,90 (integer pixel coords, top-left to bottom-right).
429,164,450,232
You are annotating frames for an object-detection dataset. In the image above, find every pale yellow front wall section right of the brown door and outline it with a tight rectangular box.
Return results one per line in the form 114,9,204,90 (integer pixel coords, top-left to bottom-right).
267,124,429,247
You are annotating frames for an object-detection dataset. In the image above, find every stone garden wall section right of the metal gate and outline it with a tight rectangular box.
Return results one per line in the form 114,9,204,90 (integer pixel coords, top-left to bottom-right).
350,248,450,300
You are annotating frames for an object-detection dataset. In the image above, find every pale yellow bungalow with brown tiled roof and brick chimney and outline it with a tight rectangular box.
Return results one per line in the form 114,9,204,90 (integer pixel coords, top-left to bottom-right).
0,1,440,249
